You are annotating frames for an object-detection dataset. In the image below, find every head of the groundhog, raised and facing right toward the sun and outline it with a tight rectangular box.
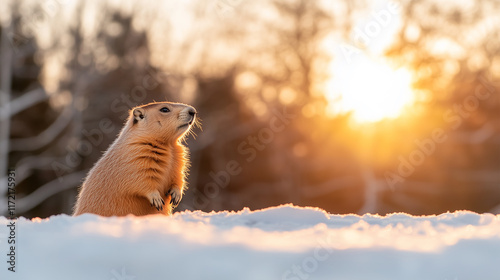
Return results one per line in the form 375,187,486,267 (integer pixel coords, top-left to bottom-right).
129,102,196,142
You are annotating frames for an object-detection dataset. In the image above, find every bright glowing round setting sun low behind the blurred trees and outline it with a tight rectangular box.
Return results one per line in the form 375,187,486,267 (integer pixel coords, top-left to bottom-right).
328,55,413,123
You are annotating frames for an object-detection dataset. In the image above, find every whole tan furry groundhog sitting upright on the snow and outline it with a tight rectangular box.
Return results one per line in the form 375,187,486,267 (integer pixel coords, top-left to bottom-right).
74,102,196,217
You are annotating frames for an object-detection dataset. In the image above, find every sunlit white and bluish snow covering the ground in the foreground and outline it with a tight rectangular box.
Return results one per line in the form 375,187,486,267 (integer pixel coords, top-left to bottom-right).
0,205,500,280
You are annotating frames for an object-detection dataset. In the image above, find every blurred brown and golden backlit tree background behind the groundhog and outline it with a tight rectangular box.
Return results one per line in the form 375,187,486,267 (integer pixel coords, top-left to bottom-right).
0,0,500,217
